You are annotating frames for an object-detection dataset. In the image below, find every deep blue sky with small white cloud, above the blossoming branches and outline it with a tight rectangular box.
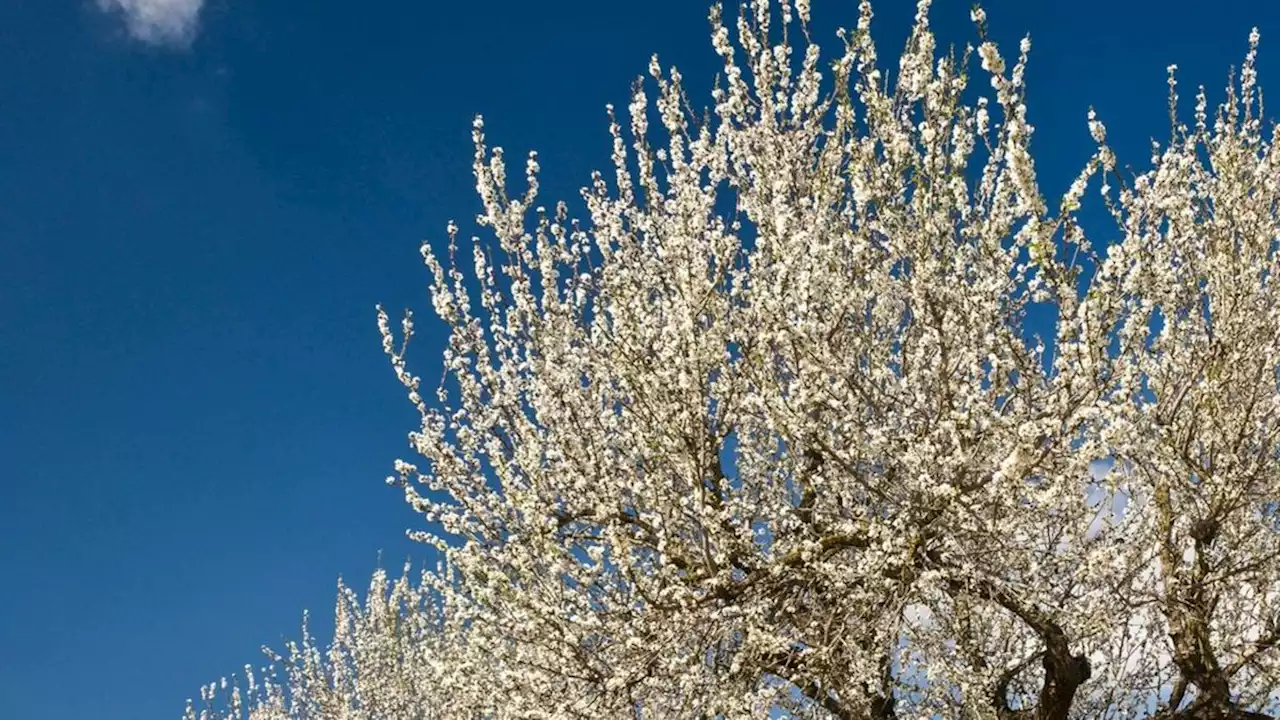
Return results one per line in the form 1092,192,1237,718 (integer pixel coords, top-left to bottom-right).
0,0,1280,720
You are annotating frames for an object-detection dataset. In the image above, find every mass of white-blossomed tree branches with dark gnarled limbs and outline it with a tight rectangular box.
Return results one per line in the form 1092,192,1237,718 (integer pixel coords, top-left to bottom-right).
188,0,1280,720
